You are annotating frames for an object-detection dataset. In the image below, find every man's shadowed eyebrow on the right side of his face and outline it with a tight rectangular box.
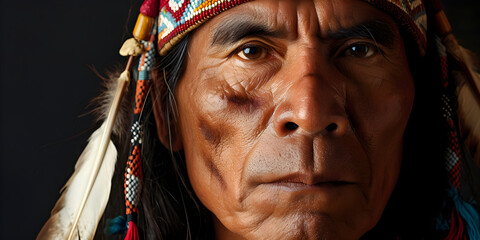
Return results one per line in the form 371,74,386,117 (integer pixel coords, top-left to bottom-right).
327,20,395,48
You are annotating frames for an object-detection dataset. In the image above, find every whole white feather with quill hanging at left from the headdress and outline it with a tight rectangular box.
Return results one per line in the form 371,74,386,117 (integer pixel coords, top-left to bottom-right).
37,56,133,240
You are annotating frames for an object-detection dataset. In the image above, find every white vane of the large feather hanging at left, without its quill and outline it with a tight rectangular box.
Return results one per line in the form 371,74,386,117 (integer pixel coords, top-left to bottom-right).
37,123,117,240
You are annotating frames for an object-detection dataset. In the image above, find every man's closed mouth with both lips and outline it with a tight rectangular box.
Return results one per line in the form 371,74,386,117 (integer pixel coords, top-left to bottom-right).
247,171,362,210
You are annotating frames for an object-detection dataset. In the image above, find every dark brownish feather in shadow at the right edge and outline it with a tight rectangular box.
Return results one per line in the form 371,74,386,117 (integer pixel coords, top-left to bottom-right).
444,34,480,166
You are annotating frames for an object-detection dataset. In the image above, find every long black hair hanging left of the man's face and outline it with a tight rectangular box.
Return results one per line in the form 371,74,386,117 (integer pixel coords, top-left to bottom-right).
139,33,213,239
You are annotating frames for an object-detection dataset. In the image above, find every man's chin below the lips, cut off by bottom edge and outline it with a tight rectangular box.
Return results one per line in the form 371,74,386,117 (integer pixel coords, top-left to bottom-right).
216,186,381,240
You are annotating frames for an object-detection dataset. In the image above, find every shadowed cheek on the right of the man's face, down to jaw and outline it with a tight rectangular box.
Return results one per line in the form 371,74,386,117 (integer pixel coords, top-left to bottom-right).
347,58,415,208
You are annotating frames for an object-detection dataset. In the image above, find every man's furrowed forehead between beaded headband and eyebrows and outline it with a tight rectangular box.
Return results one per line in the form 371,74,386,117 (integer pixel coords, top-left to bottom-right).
201,0,396,38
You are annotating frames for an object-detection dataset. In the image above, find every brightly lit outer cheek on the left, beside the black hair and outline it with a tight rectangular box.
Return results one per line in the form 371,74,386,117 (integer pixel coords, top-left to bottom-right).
177,84,230,214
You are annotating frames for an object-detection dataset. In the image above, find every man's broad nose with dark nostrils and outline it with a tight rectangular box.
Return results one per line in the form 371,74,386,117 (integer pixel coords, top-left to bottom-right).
273,49,349,137
